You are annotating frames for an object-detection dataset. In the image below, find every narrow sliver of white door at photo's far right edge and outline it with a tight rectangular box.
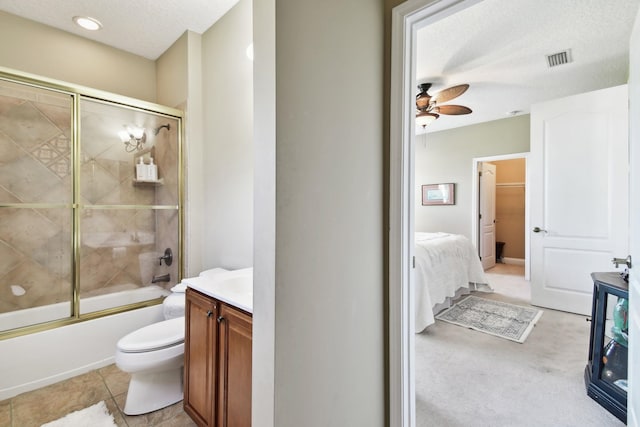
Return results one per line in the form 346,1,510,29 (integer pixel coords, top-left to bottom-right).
618,14,640,426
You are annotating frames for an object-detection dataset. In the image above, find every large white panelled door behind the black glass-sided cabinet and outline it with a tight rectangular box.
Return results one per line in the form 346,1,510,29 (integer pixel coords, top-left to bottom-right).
529,85,629,314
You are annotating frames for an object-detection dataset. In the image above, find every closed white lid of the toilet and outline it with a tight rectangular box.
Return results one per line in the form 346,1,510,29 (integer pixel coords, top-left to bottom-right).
118,317,184,353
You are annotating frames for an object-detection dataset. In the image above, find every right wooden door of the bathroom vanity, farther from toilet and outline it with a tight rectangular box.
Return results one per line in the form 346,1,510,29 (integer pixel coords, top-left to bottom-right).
216,304,253,427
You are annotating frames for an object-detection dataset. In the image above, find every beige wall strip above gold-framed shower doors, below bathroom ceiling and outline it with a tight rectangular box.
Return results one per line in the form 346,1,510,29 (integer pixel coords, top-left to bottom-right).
0,12,156,102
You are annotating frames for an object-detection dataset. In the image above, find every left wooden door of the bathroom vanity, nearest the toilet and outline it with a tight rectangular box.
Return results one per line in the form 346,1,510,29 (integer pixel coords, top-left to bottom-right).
184,289,218,426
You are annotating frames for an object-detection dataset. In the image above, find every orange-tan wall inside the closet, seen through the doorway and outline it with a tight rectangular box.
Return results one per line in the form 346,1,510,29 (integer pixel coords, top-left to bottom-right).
491,158,526,259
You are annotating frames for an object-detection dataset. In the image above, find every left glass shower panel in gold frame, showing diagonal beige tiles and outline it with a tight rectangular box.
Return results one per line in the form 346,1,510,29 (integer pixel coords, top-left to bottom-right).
0,79,74,332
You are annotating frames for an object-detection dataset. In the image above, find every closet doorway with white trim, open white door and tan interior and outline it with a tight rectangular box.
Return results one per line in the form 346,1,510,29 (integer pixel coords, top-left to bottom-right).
471,153,529,280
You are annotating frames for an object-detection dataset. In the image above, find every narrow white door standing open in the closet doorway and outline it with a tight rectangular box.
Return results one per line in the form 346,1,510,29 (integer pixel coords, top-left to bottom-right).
478,162,496,270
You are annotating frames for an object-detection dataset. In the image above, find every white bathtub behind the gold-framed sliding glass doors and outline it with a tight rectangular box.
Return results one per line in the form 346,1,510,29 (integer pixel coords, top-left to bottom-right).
0,286,167,401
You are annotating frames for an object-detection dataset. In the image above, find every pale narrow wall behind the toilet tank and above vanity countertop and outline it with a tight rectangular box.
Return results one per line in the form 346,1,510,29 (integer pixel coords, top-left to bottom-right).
204,0,253,268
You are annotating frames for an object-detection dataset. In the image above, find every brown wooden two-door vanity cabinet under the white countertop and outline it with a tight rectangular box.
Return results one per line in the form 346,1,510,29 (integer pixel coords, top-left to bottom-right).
184,288,253,427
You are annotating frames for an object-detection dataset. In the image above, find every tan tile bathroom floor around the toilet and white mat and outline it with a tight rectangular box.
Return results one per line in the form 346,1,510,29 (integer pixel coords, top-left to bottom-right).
0,365,196,427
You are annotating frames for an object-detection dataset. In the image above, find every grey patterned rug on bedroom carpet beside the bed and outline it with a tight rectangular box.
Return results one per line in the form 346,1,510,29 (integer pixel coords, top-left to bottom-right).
436,296,542,343
